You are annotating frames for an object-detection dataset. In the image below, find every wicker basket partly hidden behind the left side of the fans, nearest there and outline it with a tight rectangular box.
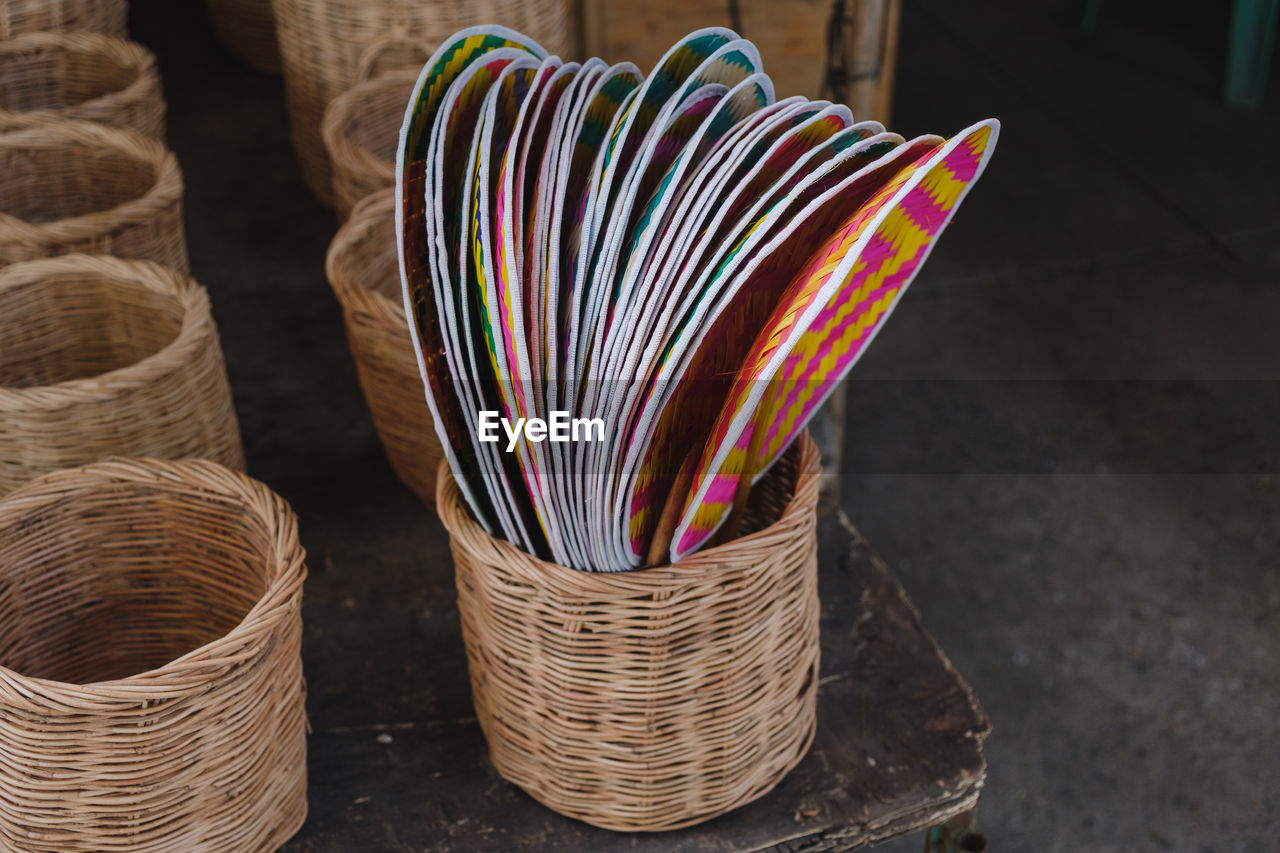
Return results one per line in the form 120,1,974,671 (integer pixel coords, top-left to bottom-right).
325,190,444,506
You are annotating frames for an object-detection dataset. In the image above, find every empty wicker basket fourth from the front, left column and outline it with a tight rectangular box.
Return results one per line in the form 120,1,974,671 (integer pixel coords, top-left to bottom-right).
0,32,164,140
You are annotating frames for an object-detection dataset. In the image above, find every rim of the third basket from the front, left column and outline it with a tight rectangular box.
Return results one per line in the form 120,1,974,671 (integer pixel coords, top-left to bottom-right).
0,111,183,247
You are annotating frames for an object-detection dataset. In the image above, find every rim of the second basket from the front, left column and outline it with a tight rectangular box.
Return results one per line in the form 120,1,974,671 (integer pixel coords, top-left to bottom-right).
0,254,212,411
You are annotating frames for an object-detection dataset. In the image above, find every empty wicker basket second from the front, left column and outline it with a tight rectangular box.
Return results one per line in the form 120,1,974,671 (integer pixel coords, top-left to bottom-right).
0,255,244,494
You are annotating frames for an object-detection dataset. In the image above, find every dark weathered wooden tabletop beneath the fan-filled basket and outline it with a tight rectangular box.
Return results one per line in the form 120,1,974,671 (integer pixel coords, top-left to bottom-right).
285,510,989,853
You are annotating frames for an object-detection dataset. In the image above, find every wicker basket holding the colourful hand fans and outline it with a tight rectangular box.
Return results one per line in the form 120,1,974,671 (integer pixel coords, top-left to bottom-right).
436,427,820,830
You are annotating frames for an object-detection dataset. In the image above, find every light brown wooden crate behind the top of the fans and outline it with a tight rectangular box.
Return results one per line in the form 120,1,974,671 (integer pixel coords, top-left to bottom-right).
579,0,901,123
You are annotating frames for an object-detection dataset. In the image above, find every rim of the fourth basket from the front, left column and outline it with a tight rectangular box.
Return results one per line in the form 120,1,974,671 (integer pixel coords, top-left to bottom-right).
0,31,160,119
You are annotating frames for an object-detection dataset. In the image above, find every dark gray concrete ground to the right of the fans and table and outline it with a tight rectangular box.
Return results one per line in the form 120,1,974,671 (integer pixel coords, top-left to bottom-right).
842,0,1280,853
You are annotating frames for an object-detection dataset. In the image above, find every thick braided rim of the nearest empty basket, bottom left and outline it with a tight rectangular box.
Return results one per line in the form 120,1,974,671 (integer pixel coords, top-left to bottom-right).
0,457,307,713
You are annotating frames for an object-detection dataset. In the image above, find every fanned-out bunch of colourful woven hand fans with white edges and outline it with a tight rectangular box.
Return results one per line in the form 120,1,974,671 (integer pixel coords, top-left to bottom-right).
397,27,998,571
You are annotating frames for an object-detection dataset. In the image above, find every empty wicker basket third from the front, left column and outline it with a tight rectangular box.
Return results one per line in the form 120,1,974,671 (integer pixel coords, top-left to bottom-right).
0,114,187,272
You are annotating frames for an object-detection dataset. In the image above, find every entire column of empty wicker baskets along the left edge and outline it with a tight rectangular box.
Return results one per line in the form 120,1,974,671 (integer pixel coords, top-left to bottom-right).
0,11,306,853
